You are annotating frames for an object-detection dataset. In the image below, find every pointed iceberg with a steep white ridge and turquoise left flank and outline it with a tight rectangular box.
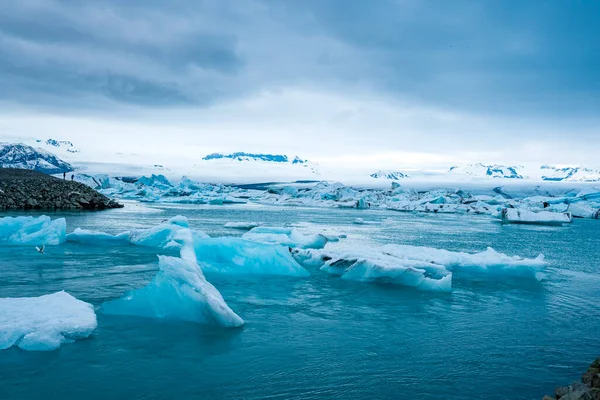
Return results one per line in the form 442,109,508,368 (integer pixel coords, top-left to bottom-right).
102,228,244,327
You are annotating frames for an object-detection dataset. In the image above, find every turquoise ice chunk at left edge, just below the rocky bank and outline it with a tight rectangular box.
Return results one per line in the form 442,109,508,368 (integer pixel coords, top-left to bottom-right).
0,215,67,245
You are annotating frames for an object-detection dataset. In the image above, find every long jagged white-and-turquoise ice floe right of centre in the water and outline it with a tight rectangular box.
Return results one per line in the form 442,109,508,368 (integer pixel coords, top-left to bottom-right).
293,241,547,292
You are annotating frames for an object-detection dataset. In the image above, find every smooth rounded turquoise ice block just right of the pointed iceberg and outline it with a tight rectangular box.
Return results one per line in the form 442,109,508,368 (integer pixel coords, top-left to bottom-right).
194,237,310,276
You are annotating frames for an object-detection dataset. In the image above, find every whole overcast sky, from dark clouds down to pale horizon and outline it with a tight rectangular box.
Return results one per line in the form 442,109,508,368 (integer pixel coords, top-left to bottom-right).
0,0,600,167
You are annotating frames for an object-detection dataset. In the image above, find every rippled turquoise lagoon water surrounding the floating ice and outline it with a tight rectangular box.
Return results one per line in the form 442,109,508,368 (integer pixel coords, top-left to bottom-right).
0,204,600,400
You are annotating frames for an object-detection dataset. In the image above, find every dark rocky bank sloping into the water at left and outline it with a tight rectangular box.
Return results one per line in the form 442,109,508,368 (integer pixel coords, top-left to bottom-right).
0,168,123,210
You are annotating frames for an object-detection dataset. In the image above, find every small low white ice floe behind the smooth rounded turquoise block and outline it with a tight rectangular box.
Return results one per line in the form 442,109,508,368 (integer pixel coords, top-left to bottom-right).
242,227,327,249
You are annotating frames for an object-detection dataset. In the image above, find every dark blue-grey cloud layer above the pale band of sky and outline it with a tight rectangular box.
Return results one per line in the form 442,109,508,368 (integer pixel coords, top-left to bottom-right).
0,0,600,116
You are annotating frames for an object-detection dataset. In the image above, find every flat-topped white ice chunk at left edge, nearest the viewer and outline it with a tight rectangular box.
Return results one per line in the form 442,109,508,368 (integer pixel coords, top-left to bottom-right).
0,292,98,350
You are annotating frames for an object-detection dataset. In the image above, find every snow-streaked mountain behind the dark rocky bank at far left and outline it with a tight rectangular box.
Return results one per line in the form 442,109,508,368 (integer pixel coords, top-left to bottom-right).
0,143,74,174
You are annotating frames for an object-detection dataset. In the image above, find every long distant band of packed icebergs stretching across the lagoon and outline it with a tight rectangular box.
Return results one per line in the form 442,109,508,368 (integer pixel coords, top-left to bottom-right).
76,175,600,222
